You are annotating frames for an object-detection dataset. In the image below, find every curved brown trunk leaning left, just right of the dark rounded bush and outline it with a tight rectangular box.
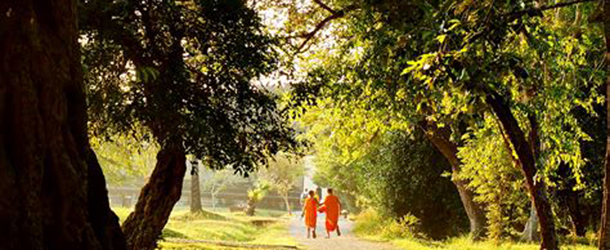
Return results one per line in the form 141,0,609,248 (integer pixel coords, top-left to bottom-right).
423,124,487,240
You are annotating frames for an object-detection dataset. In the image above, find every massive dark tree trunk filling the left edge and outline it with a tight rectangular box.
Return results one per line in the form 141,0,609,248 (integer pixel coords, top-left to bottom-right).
0,0,125,250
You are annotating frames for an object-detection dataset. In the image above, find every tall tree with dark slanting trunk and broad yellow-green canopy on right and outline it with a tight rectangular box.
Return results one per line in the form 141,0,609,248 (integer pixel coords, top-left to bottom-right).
282,0,598,249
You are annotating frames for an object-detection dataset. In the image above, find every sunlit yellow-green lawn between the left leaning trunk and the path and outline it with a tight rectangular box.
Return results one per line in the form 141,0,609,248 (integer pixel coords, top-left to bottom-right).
113,208,296,250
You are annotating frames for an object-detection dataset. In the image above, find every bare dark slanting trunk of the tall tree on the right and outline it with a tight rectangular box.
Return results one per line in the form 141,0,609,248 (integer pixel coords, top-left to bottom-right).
486,90,559,250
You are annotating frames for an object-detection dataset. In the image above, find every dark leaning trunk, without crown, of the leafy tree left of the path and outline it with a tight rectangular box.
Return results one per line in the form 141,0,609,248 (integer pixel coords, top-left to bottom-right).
123,143,186,250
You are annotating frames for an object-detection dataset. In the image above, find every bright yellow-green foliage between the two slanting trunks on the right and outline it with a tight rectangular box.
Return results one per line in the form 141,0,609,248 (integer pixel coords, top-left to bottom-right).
458,116,530,241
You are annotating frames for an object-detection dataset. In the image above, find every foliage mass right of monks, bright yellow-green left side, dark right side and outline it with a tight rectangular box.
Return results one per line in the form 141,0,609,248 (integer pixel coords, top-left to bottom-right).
301,101,466,238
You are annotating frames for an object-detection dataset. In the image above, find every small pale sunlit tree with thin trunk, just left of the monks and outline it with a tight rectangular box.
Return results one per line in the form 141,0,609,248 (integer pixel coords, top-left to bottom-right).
258,153,304,215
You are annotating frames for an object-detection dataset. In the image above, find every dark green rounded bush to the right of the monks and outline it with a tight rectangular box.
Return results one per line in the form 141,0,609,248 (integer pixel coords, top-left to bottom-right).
360,132,466,239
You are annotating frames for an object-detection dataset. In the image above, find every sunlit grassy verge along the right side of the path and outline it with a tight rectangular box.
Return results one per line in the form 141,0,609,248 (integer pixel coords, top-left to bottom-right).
352,211,597,250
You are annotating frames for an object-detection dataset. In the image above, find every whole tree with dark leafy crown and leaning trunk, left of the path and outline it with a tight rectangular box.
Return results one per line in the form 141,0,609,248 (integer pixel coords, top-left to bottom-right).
80,0,295,250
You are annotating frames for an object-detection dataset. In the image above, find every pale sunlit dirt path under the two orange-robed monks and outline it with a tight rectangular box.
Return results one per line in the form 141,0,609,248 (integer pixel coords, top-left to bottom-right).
290,212,396,250
